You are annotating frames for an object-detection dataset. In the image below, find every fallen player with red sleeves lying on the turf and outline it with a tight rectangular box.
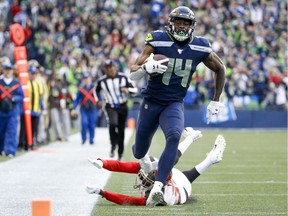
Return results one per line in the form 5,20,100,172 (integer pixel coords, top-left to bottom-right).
86,128,226,206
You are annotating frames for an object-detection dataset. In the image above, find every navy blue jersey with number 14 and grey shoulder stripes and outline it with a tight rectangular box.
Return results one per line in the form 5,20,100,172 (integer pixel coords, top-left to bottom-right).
142,30,212,105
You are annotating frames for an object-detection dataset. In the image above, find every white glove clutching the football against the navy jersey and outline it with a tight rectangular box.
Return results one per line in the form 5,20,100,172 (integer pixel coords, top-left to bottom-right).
143,53,169,74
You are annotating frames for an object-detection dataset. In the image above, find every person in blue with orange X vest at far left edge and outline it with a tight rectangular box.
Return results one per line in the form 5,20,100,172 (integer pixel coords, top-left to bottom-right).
0,62,24,158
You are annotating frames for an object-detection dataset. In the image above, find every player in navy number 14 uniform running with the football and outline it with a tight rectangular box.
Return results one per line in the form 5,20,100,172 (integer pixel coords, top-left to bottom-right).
130,6,226,207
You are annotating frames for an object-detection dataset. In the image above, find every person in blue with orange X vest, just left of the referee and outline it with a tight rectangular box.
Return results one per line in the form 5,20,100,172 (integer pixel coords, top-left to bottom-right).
71,73,98,145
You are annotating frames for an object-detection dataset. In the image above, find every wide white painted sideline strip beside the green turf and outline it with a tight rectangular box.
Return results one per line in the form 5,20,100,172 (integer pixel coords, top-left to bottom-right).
0,128,133,216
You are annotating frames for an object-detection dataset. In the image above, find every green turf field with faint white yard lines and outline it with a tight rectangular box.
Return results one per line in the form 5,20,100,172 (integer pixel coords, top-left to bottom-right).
91,130,287,216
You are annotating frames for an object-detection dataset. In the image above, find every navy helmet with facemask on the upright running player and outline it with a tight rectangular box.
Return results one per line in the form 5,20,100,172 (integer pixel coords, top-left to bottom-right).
167,6,196,41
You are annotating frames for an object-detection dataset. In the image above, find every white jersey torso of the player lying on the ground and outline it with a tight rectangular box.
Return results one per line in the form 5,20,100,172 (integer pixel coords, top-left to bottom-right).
164,168,192,205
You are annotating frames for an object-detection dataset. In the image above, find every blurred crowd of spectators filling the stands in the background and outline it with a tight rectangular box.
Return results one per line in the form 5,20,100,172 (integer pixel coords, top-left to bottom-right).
0,0,288,144
